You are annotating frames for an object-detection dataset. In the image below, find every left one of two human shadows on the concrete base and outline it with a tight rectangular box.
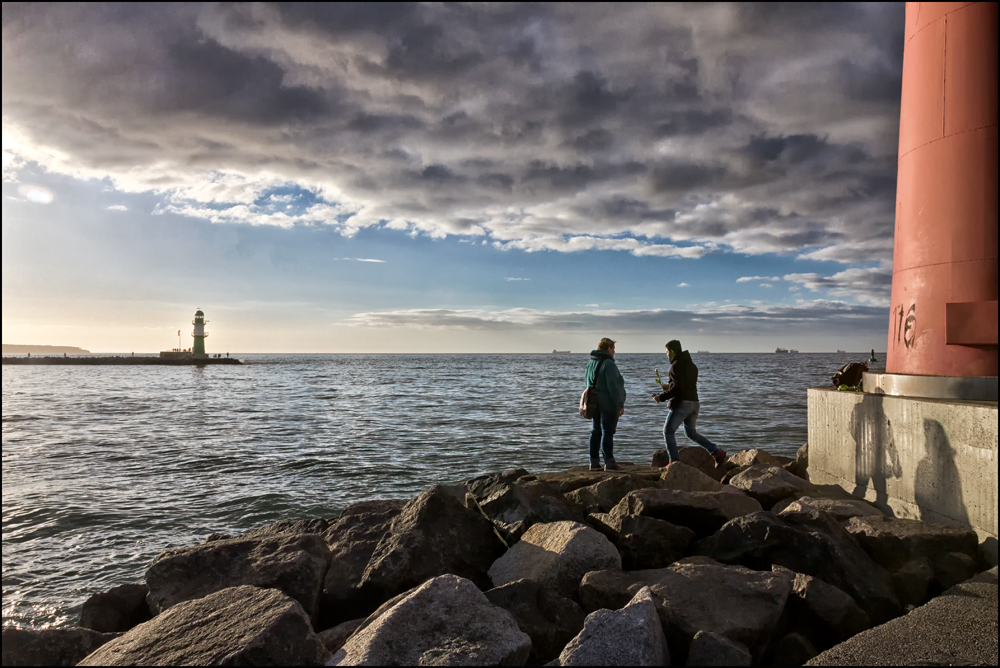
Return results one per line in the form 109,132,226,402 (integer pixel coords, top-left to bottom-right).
850,394,908,514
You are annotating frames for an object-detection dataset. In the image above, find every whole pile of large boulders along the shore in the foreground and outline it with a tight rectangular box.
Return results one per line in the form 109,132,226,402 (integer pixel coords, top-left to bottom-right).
3,446,996,666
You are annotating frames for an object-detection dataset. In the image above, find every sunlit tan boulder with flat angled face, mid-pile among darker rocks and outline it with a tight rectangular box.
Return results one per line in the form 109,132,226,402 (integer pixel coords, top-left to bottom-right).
489,522,622,598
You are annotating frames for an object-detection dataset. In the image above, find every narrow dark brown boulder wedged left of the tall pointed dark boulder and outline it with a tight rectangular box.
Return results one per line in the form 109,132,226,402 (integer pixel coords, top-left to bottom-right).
320,500,406,628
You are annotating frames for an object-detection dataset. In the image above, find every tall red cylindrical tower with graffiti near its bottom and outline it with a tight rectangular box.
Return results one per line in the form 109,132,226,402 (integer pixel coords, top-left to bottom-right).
886,2,998,377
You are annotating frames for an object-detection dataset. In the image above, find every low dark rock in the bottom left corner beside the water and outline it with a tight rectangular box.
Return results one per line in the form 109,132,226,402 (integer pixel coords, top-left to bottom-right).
3,627,121,666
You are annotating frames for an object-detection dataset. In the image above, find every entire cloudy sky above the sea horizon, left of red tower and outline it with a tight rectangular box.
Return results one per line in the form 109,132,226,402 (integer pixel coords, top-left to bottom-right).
3,3,903,352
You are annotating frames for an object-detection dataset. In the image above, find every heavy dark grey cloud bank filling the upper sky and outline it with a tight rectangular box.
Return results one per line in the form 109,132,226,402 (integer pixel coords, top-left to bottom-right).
2,3,902,270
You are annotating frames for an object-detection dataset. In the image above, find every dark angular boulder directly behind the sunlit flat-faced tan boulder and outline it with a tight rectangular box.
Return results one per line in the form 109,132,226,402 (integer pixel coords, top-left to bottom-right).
466,469,583,546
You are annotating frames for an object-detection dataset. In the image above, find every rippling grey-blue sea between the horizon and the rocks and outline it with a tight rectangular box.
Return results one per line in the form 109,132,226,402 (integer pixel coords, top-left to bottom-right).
3,353,867,628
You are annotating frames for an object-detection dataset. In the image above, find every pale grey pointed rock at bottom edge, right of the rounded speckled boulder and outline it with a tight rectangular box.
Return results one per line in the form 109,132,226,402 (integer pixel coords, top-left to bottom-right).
559,587,670,666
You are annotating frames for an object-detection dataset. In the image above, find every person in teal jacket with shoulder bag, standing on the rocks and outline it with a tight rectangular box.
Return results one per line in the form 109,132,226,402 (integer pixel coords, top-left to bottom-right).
584,338,625,473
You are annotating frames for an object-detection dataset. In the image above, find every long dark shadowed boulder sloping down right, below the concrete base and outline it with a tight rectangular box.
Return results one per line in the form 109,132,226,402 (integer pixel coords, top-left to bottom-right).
699,510,900,624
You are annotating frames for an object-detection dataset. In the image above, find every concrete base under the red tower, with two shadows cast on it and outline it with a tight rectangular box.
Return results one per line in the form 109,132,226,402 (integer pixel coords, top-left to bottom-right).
808,386,998,565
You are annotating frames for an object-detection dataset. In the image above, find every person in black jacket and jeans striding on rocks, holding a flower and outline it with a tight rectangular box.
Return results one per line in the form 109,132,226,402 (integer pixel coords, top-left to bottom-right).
653,339,726,468
